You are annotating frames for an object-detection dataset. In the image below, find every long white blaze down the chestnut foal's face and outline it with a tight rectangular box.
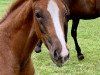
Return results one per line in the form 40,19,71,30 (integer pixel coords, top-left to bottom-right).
47,0,68,57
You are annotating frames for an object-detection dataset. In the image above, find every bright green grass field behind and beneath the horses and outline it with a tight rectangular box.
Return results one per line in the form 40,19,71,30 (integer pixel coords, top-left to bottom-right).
0,0,100,75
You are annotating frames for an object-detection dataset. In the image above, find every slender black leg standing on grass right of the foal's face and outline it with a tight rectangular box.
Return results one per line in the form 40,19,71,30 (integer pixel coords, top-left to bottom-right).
71,19,84,60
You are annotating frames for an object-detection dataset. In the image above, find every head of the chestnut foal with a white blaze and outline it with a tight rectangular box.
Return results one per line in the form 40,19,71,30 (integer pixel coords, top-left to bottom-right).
34,0,69,66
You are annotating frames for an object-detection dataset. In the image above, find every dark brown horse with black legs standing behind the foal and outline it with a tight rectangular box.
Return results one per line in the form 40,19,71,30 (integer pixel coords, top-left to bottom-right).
35,0,100,60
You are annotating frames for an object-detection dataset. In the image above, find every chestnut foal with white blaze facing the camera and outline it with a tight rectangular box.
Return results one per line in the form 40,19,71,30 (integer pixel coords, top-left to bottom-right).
0,0,69,75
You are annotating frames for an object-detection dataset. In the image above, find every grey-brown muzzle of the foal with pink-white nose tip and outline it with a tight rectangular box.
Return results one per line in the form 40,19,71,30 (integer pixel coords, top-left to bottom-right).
45,36,69,67
